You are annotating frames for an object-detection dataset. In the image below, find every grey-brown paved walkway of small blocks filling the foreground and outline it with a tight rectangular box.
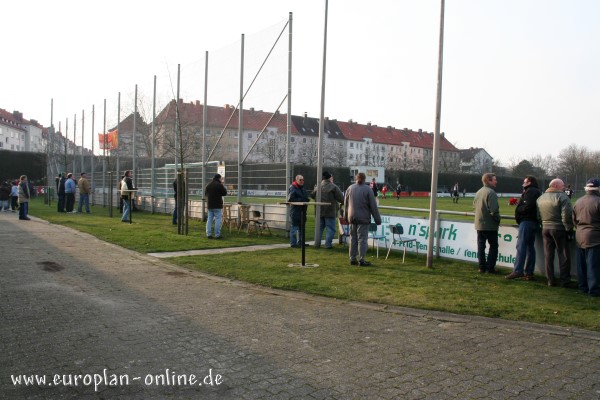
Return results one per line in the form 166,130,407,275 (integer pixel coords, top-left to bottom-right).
0,213,600,400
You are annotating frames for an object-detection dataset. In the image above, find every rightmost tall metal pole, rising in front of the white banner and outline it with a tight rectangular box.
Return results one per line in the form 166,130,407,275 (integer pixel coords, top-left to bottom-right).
427,0,445,268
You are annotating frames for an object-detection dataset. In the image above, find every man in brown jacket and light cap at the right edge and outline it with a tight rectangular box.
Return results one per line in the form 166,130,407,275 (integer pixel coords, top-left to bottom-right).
573,178,600,297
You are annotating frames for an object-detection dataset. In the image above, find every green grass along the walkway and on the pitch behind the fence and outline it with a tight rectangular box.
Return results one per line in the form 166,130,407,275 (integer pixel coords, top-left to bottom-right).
25,198,600,331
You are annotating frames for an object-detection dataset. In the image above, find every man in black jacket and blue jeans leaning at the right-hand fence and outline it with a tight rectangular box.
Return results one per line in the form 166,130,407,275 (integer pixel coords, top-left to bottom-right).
505,175,542,281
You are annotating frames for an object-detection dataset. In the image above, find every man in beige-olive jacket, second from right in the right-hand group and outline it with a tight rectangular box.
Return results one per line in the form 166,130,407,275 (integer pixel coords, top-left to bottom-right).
537,178,573,287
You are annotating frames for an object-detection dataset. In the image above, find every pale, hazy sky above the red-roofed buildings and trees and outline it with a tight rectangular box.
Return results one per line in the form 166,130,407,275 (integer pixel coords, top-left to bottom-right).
0,0,600,166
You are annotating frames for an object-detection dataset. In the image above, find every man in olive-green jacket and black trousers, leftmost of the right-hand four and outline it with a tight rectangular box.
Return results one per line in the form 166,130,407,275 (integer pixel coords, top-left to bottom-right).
473,172,500,274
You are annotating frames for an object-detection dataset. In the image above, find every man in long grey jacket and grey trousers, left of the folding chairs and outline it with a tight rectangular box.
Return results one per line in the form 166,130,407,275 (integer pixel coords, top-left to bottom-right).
344,172,381,266
